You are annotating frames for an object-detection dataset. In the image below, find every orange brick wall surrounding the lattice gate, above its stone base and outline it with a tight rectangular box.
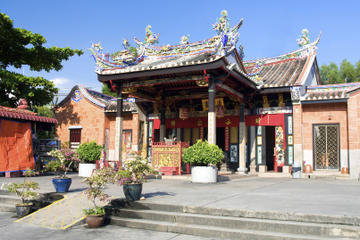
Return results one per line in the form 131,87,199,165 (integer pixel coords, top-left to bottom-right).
302,103,348,150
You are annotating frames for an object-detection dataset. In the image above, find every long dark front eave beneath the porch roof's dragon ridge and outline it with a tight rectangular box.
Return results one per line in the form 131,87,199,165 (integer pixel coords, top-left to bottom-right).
97,57,226,82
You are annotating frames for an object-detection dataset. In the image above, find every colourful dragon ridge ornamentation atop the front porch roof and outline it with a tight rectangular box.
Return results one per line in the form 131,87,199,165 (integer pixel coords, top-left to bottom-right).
89,10,243,72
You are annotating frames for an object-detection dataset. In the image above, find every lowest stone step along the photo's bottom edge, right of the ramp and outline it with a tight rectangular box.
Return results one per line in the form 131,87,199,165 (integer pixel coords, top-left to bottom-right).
111,216,338,240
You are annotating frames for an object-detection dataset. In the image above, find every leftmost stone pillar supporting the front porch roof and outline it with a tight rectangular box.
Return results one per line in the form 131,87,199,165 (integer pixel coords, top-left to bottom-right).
114,85,123,166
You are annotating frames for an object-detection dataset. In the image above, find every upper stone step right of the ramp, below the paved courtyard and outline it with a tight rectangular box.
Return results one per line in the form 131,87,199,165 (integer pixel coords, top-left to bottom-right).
116,201,360,226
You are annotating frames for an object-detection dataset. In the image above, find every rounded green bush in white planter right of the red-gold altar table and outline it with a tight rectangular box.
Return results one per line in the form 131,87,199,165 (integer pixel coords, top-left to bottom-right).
182,140,224,166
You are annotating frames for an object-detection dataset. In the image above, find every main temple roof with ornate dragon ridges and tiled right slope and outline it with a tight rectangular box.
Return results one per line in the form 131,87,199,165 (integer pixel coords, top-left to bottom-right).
90,10,321,94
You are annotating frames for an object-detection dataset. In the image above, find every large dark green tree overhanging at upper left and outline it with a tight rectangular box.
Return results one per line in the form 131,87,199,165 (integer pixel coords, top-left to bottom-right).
0,13,83,107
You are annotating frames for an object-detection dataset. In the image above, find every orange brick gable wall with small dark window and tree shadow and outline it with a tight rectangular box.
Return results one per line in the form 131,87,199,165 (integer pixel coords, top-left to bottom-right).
55,97,105,145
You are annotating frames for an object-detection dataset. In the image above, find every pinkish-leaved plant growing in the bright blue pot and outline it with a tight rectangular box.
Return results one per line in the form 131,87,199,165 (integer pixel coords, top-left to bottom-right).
45,148,80,178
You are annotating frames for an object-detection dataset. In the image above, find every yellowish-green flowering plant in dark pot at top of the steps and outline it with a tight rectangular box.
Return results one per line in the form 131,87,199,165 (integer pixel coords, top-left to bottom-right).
115,154,157,184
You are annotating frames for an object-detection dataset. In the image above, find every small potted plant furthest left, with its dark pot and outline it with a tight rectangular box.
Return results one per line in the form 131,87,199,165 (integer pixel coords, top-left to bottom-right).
7,170,39,217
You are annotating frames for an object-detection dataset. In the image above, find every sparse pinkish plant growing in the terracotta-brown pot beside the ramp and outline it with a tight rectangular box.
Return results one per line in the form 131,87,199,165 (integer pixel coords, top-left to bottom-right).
83,168,115,215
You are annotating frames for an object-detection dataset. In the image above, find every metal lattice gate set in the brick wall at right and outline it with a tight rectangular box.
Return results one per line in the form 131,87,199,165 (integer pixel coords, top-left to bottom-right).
313,124,340,170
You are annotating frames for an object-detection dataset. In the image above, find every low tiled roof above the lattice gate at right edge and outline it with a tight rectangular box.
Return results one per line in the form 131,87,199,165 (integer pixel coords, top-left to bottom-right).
301,83,360,102
